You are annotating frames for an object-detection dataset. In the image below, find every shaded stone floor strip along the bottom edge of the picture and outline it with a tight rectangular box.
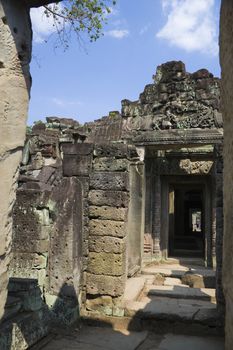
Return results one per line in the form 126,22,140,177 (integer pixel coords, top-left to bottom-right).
33,326,224,350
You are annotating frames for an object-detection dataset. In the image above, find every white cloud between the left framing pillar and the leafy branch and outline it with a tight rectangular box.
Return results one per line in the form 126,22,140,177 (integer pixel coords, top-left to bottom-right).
30,5,61,43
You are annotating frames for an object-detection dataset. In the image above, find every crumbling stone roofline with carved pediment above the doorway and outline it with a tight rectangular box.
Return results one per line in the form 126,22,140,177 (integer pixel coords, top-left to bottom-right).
28,61,222,143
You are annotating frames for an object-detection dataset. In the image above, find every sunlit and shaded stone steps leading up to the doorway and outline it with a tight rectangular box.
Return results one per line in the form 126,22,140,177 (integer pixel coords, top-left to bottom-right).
125,259,219,335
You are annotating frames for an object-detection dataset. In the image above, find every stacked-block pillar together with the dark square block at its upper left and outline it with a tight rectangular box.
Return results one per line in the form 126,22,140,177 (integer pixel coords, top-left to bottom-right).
62,143,133,315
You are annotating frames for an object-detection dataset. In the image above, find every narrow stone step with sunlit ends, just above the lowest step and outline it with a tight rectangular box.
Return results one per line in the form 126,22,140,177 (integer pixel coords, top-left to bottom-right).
146,285,216,303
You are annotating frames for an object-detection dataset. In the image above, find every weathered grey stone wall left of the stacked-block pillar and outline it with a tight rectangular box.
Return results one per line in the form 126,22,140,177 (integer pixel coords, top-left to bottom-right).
10,124,84,324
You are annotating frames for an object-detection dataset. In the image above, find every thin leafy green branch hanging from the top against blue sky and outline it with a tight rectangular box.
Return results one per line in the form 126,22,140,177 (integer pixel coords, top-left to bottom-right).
44,0,116,48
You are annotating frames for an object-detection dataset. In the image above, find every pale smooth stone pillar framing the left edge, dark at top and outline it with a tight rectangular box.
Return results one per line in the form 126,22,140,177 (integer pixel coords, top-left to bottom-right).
0,0,32,318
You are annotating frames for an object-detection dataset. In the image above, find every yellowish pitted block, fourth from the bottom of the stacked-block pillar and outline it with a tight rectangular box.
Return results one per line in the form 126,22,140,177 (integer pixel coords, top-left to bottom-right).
89,236,126,254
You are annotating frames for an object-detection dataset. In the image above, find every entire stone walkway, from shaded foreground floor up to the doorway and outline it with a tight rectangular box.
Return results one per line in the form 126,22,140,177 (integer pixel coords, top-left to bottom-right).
32,258,224,350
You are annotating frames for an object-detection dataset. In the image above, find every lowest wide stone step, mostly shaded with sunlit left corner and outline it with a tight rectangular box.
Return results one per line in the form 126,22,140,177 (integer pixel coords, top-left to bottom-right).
125,296,223,335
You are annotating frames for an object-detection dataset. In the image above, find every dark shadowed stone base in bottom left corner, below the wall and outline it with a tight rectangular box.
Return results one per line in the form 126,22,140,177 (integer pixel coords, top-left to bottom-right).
0,278,79,350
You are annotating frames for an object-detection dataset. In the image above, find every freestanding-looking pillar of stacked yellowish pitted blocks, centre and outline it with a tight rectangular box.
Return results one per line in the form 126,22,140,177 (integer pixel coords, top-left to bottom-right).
85,143,130,316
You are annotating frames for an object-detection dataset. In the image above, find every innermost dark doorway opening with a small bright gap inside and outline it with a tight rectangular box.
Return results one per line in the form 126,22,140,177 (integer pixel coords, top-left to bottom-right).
169,184,205,257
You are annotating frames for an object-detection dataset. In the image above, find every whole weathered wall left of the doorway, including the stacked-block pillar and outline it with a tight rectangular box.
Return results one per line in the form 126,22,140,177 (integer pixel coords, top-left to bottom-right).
10,118,139,323
